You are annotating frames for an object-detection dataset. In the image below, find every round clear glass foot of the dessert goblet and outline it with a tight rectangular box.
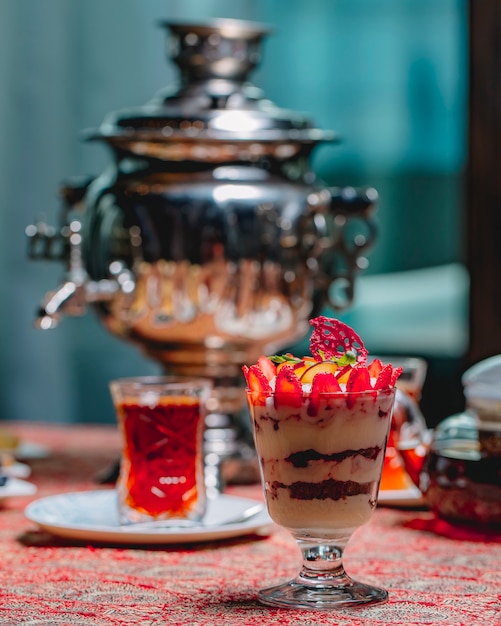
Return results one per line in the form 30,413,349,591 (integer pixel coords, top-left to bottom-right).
258,577,388,611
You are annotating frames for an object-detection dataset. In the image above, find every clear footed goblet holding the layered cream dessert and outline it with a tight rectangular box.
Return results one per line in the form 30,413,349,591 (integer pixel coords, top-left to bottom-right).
247,388,396,610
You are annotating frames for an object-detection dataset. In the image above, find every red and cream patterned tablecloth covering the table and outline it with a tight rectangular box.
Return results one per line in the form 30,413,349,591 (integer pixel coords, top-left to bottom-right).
0,423,501,626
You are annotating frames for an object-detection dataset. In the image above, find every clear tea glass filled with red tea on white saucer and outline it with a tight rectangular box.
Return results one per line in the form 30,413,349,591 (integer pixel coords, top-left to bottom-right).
110,376,211,524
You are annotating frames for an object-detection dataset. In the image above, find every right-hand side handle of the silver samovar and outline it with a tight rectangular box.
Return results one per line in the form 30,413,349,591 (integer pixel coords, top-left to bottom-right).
308,187,378,311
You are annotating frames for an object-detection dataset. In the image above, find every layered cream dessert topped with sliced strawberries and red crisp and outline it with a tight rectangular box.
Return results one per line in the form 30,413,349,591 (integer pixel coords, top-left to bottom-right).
244,317,401,537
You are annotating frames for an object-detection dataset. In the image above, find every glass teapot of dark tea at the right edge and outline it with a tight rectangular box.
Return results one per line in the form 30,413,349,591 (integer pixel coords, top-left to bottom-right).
397,355,501,529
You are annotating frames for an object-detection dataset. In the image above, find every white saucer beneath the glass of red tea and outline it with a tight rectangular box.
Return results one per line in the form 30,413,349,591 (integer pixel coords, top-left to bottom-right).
25,489,272,544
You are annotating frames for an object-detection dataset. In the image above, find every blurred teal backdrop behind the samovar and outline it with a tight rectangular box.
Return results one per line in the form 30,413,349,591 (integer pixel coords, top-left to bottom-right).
0,0,468,422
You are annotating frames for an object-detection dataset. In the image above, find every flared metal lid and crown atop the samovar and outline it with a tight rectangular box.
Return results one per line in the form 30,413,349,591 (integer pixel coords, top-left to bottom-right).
88,19,337,144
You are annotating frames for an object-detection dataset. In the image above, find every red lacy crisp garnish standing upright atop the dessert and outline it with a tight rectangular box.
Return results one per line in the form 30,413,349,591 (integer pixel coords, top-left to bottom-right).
310,315,367,365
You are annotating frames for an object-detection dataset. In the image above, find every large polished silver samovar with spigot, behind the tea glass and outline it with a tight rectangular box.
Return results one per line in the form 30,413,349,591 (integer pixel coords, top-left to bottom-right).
27,20,377,486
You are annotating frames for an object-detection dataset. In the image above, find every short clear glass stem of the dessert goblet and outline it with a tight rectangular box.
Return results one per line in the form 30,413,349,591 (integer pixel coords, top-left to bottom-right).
296,536,352,588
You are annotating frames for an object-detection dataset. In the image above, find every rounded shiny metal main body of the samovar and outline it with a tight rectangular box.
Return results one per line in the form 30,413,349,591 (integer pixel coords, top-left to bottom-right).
82,162,369,377
